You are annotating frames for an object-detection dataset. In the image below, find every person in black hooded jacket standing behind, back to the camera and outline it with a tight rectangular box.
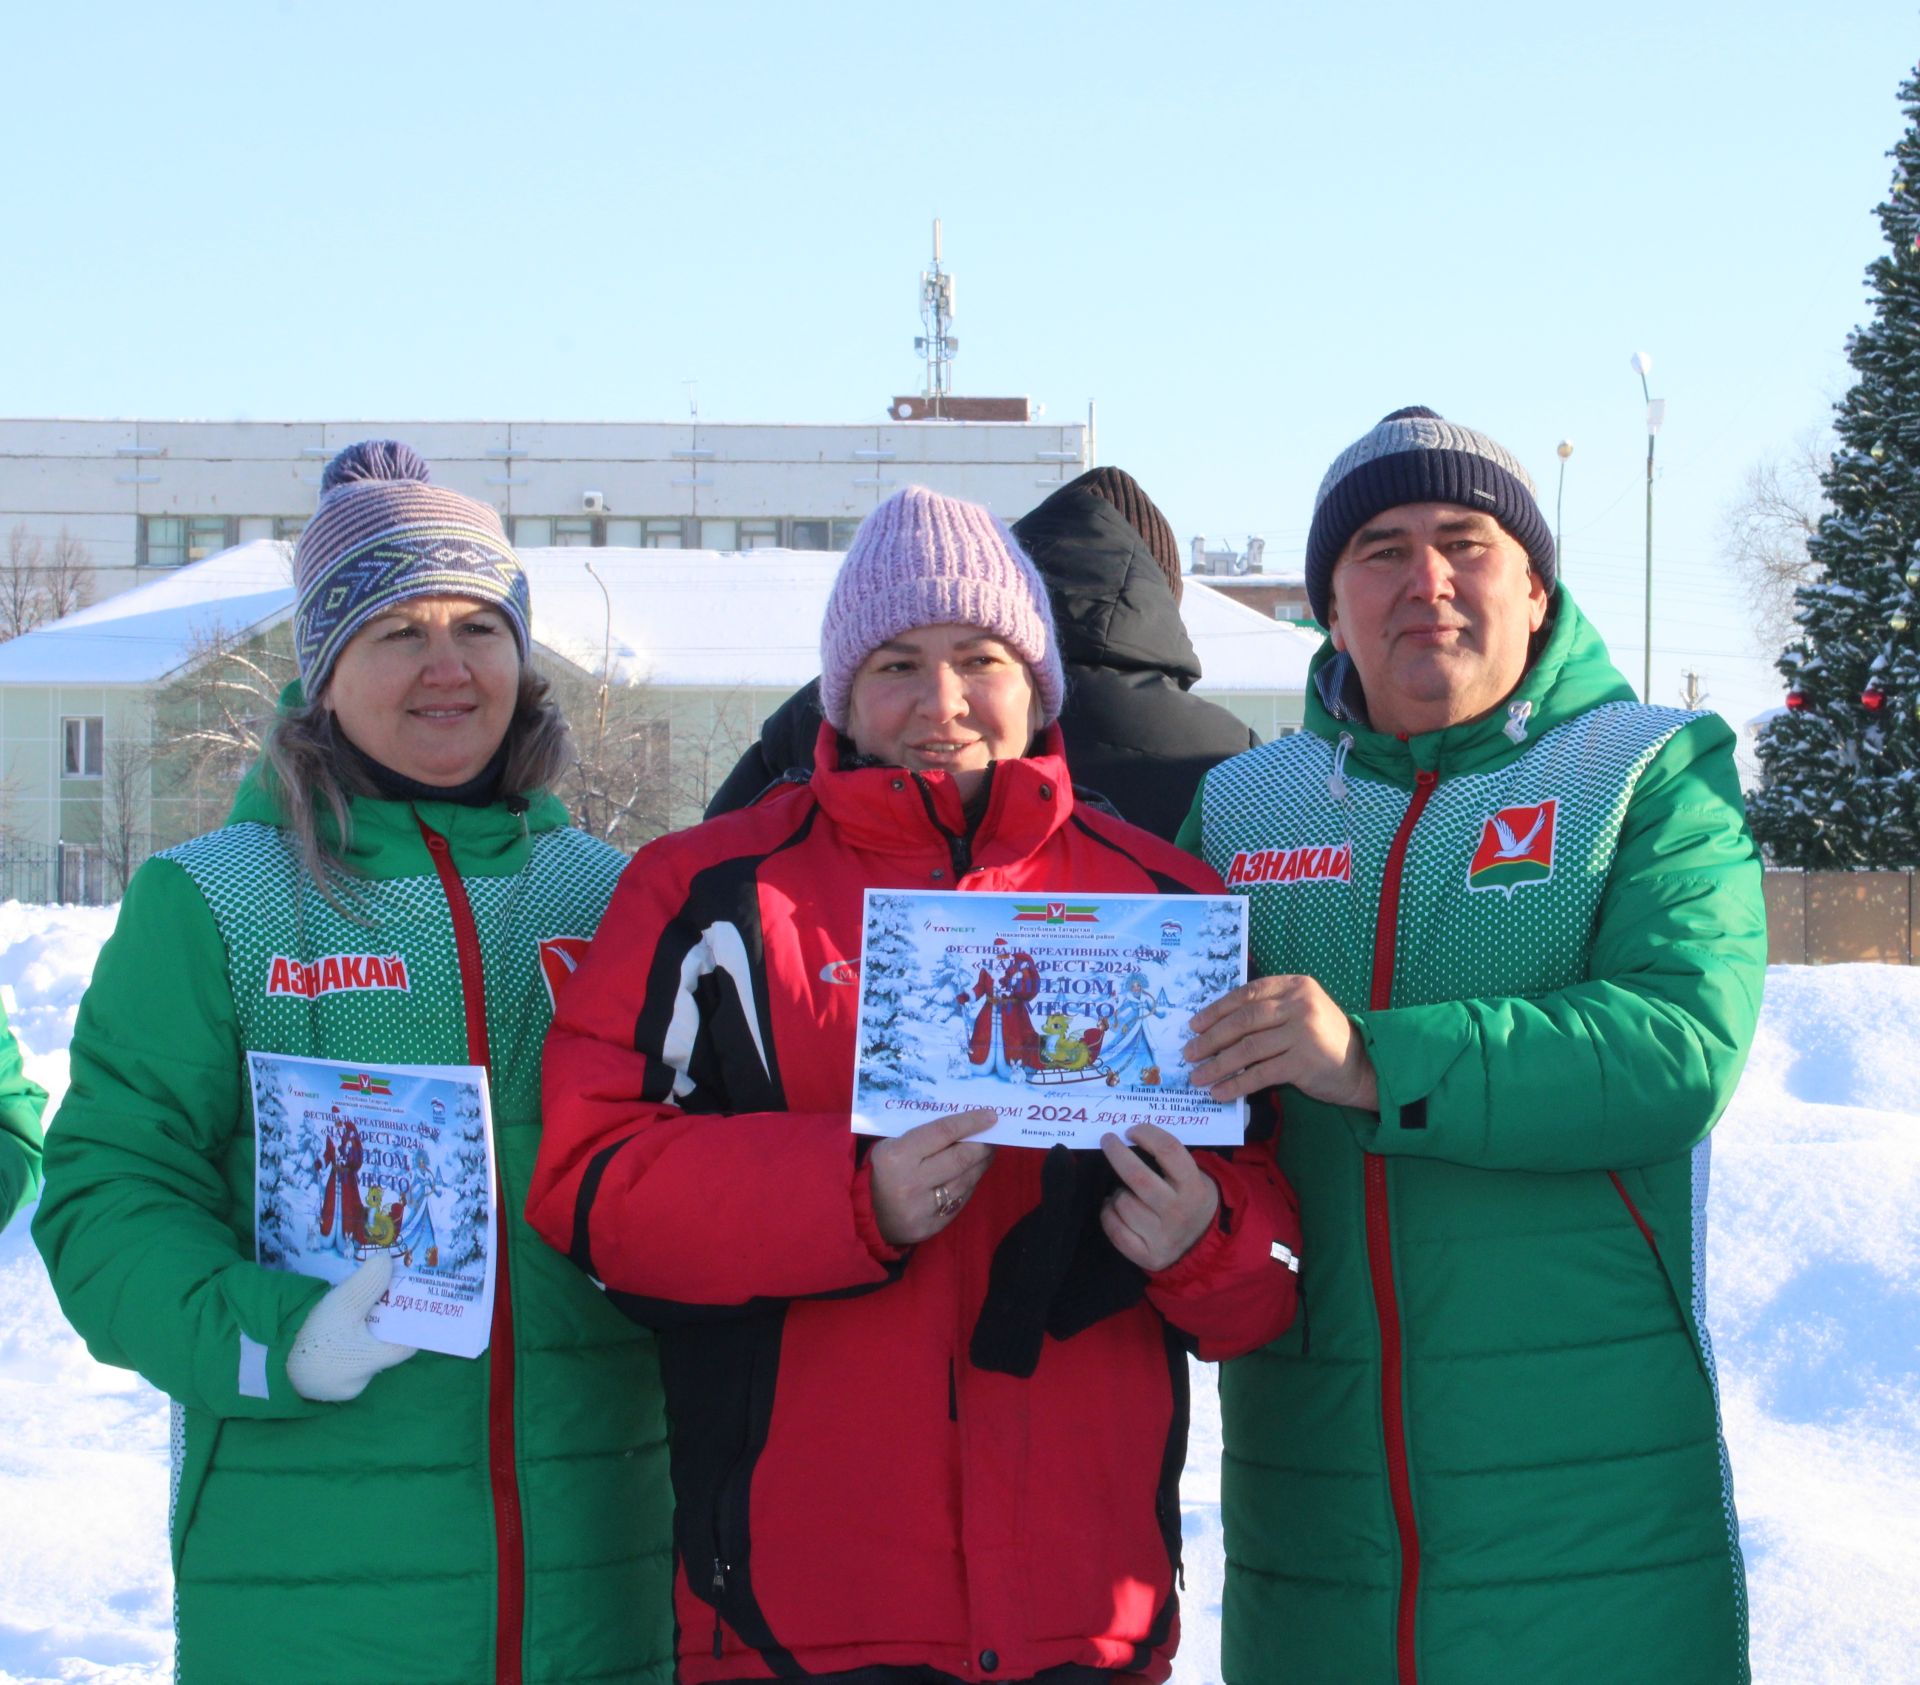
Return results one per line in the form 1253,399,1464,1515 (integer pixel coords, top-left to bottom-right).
707,468,1260,841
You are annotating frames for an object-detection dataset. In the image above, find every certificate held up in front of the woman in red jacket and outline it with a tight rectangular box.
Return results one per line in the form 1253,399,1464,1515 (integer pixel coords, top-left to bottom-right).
852,889,1246,1148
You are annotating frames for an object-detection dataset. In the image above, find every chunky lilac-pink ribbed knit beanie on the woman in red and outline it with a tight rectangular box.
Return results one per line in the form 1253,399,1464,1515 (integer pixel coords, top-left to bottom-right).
820,486,1066,731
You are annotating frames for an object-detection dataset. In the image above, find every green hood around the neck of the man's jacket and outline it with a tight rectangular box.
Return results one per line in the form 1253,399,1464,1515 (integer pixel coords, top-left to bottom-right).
1306,585,1636,777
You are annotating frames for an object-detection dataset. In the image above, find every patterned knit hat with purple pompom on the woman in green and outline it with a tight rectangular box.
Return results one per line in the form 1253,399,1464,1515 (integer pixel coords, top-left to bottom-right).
294,439,532,700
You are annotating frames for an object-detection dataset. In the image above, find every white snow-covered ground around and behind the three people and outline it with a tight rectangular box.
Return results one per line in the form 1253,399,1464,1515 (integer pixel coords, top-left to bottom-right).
0,902,1920,1685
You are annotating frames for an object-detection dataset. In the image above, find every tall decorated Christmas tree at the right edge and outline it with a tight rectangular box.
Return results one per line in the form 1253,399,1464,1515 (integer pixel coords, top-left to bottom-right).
1747,69,1920,867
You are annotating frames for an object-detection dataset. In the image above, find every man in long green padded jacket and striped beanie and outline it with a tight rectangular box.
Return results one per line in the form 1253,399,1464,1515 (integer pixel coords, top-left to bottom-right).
1183,409,1766,1685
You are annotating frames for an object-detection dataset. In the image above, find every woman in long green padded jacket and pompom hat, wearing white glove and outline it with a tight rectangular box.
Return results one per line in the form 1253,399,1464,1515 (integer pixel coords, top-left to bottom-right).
35,441,672,1685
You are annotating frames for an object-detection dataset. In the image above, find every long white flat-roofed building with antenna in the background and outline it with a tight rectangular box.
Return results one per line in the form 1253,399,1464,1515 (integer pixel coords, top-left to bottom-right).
0,416,1091,599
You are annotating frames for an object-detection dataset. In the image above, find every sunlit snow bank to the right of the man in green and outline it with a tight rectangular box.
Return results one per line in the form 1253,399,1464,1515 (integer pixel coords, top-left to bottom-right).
1709,965,1920,1685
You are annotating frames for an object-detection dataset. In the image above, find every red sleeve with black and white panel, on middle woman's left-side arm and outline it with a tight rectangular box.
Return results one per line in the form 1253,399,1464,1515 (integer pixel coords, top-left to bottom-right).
526,825,900,1322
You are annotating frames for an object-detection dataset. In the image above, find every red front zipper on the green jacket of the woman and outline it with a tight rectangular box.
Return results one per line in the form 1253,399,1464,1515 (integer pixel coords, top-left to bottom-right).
419,819,526,1685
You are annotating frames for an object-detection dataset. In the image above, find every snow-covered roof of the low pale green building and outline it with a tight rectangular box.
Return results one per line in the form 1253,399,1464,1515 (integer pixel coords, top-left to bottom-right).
0,539,1319,693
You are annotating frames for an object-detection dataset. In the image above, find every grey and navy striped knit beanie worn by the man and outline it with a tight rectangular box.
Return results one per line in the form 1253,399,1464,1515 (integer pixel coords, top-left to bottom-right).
1308,403,1557,626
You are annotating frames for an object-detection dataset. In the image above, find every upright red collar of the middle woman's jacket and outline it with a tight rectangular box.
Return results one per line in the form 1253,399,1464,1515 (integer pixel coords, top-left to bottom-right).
808,725,1073,867
